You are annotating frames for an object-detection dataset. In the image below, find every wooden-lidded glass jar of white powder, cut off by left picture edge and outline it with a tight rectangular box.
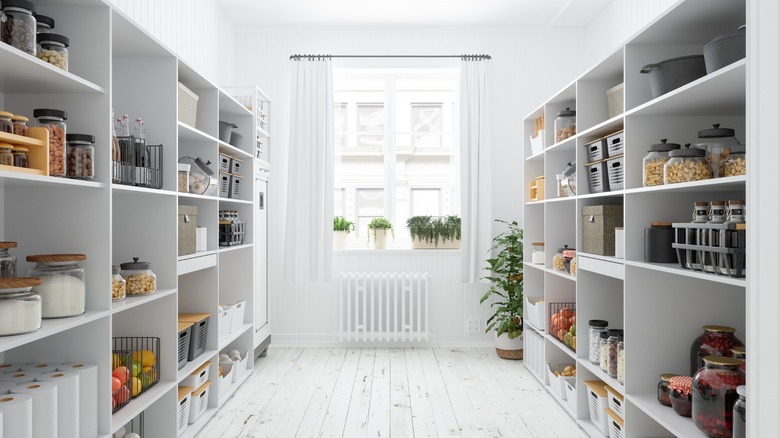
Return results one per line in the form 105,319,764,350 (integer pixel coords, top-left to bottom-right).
0,277,41,336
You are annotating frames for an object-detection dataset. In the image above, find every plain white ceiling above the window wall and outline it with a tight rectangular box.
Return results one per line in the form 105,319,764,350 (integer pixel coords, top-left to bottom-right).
216,0,612,28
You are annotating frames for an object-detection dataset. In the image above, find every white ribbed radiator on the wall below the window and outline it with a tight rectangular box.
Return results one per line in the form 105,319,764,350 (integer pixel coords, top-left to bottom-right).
338,272,429,342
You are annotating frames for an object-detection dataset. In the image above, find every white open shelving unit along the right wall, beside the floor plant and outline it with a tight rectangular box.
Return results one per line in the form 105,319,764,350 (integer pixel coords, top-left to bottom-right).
524,0,751,438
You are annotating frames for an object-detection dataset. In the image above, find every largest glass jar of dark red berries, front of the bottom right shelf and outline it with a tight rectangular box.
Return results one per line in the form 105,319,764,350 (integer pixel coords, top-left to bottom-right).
693,356,745,438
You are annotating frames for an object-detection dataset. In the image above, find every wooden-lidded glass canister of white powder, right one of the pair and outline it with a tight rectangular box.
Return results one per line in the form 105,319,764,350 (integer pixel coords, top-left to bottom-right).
27,254,87,318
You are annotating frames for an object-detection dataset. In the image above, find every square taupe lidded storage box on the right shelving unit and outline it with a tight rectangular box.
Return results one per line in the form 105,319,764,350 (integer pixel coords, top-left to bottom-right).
581,205,623,256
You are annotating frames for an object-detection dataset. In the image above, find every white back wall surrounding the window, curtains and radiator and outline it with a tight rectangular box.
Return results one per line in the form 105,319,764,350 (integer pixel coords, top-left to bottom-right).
236,28,585,345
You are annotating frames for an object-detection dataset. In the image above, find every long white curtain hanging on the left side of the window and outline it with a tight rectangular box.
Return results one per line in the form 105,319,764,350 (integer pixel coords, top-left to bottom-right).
284,59,333,283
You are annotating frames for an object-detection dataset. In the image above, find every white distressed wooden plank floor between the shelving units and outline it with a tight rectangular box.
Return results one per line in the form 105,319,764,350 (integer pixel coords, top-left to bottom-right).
198,348,587,438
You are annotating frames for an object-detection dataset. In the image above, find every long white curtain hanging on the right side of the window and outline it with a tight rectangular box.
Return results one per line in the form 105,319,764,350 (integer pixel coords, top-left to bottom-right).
460,60,492,283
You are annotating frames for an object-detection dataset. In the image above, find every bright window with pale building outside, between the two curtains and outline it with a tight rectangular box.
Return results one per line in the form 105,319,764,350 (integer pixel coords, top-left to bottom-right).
333,69,460,248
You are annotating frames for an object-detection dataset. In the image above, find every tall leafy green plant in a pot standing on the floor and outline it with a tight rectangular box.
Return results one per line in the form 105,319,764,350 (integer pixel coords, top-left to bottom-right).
479,220,523,359
